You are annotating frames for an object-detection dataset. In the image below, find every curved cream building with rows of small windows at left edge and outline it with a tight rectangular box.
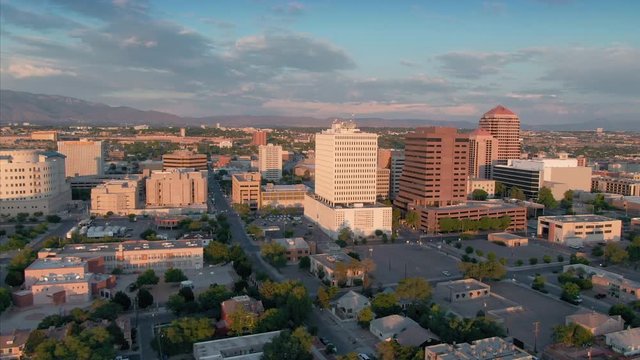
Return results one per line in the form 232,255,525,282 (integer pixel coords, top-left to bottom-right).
0,150,71,216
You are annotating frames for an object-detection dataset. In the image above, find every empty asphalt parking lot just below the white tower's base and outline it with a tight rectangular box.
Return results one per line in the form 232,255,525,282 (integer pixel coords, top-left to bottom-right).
349,244,461,285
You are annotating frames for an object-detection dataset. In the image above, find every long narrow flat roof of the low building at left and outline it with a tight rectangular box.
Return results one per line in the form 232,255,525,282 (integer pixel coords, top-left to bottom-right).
41,239,202,254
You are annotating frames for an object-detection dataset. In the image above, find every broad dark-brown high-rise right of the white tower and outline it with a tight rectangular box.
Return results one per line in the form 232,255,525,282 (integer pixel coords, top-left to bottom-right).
394,127,469,211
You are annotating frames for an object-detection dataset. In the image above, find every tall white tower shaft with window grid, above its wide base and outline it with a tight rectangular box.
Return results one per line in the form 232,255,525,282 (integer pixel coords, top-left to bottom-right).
315,121,378,206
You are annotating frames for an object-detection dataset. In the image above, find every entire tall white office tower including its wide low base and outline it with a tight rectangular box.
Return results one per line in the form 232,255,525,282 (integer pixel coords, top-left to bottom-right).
305,120,391,237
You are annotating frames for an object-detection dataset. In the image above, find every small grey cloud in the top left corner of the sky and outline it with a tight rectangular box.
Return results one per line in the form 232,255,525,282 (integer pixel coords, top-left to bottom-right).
0,2,82,30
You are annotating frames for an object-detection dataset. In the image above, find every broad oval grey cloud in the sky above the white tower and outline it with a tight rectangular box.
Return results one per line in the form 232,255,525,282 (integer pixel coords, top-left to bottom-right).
232,33,355,72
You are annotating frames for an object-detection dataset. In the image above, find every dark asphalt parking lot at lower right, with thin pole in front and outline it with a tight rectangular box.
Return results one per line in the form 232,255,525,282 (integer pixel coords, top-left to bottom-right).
491,281,580,349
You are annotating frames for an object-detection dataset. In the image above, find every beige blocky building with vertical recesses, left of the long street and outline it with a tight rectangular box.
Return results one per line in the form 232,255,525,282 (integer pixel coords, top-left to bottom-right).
147,169,207,207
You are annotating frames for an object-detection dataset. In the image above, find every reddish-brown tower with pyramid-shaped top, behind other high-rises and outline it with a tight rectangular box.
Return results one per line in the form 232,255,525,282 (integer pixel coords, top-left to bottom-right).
480,105,521,164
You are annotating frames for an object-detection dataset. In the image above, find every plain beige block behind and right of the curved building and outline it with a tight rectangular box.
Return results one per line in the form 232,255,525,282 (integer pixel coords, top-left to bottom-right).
58,139,105,177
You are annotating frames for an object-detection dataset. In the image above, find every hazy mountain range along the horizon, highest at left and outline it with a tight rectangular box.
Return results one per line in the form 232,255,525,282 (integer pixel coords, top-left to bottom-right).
0,90,640,131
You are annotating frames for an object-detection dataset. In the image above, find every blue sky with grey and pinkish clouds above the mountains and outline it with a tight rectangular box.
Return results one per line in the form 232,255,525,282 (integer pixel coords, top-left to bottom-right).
0,0,640,125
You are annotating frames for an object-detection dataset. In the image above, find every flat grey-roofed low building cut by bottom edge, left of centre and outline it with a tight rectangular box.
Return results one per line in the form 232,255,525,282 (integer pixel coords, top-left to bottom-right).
193,330,281,360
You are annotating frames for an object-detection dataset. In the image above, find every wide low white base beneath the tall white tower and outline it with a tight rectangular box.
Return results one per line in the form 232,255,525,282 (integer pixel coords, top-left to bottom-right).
304,193,392,239
